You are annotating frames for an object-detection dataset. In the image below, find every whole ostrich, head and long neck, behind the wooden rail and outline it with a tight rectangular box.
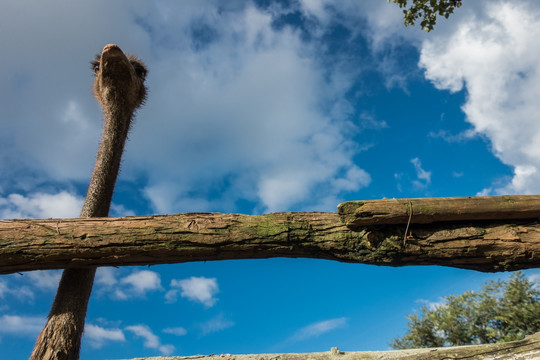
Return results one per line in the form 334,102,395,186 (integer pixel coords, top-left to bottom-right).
30,44,147,360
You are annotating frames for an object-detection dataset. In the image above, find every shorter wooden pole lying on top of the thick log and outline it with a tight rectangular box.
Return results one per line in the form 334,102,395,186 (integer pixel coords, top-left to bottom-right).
338,195,540,226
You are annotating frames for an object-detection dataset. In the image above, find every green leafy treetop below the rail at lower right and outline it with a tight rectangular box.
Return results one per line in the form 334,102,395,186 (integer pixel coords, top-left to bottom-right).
390,271,540,349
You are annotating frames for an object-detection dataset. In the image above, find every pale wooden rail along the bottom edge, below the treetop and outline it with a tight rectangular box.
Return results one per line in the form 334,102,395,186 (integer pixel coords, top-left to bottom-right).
120,333,540,360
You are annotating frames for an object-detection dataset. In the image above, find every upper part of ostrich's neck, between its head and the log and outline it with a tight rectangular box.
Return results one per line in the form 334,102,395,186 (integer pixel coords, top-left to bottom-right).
80,106,133,217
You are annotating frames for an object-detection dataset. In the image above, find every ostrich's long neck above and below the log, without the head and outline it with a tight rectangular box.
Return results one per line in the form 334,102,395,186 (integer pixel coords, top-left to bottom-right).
30,102,137,360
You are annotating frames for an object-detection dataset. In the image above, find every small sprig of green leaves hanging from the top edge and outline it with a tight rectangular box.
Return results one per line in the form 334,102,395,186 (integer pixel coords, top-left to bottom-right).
388,0,461,32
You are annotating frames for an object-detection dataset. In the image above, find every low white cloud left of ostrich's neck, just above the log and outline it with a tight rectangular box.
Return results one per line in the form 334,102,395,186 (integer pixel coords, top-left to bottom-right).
0,191,84,219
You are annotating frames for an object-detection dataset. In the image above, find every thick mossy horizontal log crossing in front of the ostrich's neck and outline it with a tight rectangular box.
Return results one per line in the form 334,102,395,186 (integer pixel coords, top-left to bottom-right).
0,212,540,273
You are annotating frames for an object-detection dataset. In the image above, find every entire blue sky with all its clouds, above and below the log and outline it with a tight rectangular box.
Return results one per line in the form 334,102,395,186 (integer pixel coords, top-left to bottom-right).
0,0,540,360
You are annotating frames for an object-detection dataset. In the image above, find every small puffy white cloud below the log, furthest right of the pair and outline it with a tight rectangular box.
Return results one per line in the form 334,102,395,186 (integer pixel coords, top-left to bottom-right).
170,276,219,307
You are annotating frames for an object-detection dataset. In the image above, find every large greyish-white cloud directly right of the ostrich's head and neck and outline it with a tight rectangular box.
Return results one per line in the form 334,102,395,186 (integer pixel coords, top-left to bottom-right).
126,2,372,212
